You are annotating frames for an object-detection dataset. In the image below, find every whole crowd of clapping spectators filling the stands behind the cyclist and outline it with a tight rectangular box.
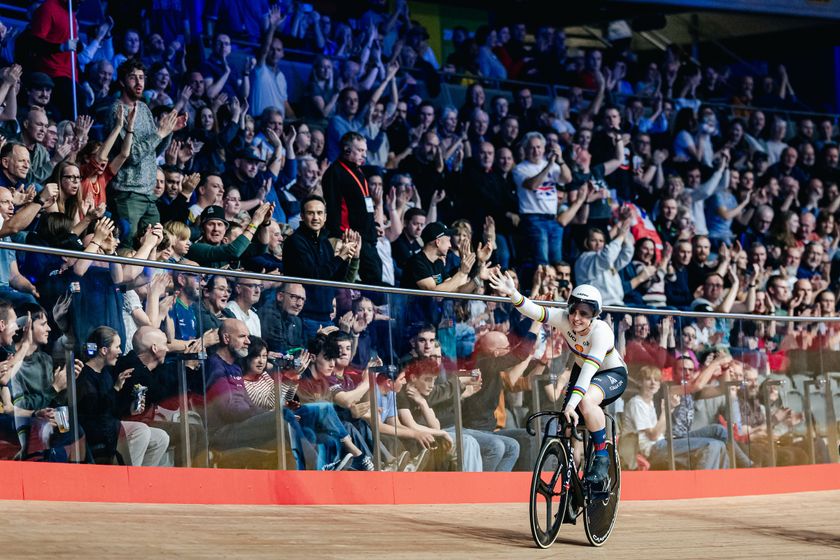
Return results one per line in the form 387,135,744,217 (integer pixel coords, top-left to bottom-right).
0,0,840,471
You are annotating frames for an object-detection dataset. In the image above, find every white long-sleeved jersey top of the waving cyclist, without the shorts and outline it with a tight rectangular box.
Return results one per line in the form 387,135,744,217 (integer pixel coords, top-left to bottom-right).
511,292,627,408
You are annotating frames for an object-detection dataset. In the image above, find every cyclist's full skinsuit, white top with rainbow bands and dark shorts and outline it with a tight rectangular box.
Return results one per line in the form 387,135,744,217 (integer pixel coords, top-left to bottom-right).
511,292,627,408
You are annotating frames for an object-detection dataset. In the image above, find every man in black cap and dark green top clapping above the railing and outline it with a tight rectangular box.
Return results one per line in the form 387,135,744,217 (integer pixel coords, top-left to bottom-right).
187,203,272,268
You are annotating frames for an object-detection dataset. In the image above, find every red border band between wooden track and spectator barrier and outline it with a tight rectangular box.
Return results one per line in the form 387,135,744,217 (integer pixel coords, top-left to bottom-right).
0,461,840,505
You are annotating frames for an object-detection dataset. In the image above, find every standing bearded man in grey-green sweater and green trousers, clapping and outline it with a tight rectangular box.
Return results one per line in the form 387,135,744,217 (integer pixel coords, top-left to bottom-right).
105,59,186,246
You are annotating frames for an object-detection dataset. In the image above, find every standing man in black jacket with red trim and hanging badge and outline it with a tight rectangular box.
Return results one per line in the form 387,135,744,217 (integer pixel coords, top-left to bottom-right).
324,132,382,284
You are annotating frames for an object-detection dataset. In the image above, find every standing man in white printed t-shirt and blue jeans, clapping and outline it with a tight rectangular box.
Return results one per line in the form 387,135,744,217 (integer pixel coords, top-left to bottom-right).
513,132,572,280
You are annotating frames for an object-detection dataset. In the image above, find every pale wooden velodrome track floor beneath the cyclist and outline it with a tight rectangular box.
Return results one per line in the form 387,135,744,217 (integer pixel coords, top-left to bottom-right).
8,491,840,560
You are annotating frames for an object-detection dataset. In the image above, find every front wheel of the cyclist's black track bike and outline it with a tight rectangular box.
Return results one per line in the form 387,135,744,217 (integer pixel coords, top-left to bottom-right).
529,438,569,548
